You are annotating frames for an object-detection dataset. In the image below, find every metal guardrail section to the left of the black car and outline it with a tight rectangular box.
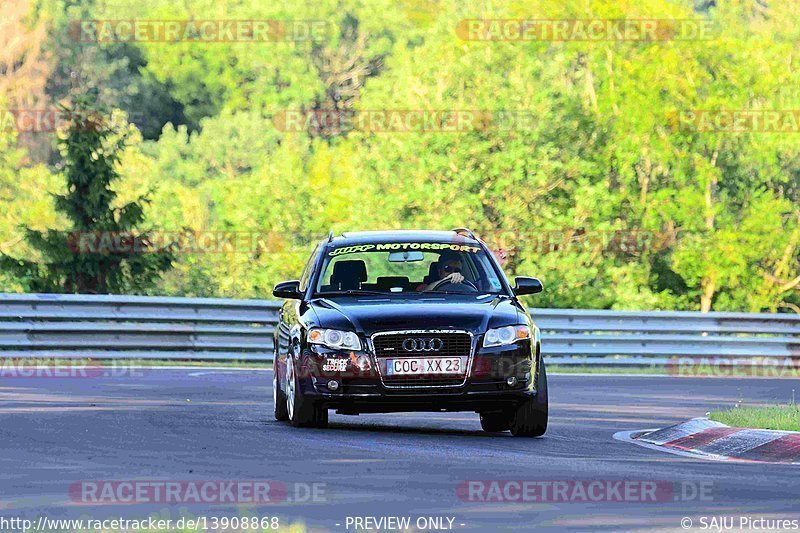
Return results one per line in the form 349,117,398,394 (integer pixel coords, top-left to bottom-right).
0,294,280,360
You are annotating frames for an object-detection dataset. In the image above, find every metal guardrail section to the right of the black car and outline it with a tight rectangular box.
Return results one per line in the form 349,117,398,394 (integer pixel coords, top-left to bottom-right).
530,309,800,365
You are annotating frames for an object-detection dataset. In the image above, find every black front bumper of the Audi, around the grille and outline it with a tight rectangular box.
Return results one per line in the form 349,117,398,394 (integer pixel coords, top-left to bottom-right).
300,341,537,414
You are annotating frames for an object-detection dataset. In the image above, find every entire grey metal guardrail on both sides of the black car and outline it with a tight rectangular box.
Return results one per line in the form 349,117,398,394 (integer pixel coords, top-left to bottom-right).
0,294,800,365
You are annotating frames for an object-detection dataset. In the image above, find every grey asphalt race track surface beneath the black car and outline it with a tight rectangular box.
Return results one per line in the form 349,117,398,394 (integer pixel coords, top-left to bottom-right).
0,368,800,531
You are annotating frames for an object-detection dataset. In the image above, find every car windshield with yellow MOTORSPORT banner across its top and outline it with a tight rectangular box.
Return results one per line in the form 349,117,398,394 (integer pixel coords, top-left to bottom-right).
315,242,503,296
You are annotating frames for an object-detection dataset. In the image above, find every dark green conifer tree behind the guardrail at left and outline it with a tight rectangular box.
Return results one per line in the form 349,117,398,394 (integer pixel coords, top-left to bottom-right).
0,98,174,294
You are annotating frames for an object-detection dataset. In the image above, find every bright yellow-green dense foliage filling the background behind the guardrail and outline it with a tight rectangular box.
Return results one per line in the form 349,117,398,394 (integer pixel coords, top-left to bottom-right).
0,0,800,312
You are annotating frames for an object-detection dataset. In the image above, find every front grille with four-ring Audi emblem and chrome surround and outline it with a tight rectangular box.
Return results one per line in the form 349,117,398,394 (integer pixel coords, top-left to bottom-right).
372,331,472,387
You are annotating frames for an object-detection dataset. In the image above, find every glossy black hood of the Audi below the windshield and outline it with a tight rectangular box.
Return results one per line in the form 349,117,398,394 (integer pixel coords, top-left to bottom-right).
311,295,525,335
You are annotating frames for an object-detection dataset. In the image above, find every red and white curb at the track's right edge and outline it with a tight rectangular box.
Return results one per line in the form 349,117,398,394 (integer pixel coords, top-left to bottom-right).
614,418,800,464
